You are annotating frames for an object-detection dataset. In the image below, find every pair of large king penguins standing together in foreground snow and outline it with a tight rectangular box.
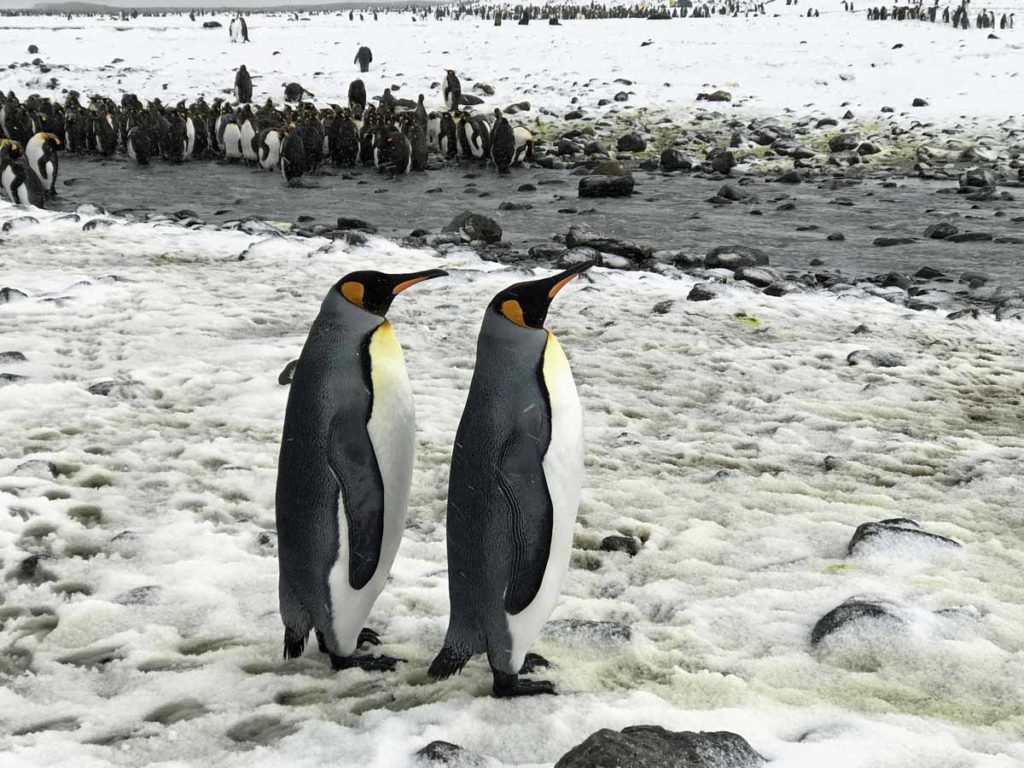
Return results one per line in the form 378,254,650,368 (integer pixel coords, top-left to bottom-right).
276,263,591,697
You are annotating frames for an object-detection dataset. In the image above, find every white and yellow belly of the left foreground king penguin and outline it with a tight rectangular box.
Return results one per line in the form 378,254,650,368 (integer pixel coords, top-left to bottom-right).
328,321,416,656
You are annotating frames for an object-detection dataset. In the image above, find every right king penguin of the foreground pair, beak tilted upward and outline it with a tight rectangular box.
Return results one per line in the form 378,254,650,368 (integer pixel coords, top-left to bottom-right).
429,262,591,697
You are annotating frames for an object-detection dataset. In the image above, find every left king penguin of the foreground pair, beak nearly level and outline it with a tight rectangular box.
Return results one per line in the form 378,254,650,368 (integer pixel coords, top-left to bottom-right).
276,269,446,671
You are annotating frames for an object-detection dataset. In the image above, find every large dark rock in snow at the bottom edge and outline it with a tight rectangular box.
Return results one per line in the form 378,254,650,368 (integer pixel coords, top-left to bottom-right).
555,725,765,768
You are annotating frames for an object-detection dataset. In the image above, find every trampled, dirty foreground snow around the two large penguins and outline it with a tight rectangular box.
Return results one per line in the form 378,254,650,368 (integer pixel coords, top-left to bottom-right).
0,204,1024,768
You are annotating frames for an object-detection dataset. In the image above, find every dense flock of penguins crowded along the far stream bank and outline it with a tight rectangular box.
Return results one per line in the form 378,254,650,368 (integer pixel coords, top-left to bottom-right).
0,66,537,207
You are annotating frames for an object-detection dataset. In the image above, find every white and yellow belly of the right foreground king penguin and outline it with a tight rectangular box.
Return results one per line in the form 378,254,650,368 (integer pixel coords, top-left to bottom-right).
505,332,583,672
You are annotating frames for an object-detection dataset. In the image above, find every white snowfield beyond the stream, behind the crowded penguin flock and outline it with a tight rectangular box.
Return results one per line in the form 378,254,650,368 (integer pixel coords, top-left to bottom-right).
6,0,1024,125
